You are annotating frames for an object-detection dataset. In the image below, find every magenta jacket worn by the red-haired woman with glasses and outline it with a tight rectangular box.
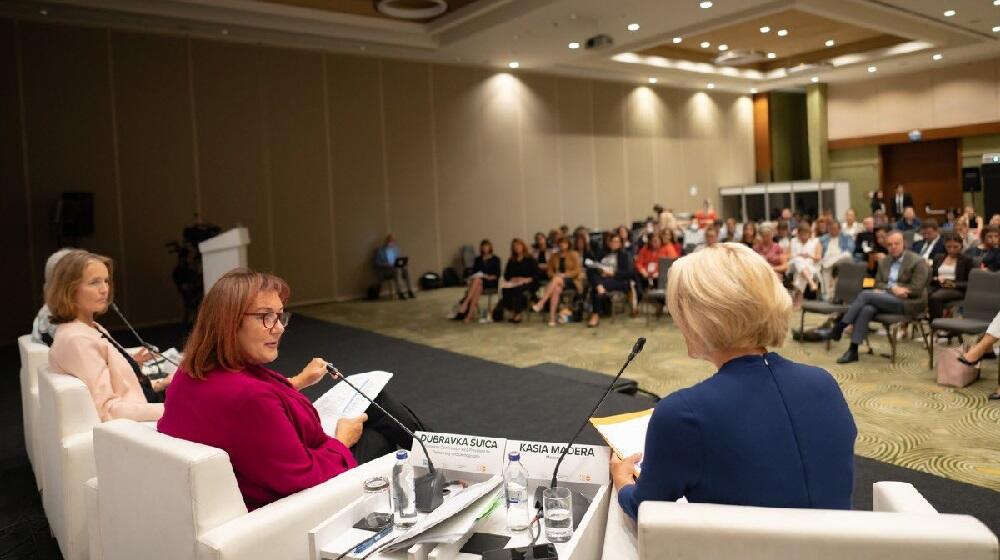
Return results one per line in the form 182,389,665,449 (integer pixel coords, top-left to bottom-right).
156,366,358,511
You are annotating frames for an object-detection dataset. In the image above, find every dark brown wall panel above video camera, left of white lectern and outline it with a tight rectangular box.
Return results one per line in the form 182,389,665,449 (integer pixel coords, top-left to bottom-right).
112,33,197,323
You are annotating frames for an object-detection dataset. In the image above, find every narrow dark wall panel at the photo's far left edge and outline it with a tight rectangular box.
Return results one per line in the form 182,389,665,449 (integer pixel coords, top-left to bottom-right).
0,20,35,340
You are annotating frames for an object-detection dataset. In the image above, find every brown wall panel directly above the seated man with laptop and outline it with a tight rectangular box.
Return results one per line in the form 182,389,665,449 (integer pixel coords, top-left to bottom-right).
382,60,442,281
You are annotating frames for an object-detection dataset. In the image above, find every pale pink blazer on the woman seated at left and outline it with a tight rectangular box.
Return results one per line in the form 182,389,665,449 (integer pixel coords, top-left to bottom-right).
49,321,163,422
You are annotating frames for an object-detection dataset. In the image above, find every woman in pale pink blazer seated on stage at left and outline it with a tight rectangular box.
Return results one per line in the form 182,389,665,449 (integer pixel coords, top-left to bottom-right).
45,250,173,422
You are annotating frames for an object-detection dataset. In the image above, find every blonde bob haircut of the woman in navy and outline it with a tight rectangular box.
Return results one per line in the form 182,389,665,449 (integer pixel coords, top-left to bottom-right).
667,243,792,358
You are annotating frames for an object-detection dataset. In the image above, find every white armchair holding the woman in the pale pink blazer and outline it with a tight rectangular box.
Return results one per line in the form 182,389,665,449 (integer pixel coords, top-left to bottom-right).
37,367,100,560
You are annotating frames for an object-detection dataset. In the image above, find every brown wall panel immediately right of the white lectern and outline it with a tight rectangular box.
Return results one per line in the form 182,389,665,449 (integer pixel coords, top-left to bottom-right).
260,49,334,303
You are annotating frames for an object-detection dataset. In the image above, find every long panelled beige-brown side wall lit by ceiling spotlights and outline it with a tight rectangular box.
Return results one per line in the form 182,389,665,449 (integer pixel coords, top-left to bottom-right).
0,20,753,340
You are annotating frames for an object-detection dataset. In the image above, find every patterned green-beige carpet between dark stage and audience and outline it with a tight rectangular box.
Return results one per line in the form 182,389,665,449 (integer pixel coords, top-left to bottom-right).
293,288,1000,491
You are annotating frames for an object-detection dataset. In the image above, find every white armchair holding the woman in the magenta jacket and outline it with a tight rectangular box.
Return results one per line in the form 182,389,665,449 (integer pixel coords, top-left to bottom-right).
90,420,394,560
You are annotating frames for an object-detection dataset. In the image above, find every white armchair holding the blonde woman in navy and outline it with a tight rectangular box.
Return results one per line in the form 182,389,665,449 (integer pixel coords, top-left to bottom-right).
636,482,998,560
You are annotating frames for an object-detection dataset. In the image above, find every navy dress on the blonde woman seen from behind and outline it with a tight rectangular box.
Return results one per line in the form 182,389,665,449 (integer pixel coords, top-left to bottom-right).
618,353,857,518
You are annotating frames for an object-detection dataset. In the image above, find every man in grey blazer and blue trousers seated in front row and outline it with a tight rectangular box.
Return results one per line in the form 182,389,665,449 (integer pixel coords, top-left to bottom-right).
829,231,930,364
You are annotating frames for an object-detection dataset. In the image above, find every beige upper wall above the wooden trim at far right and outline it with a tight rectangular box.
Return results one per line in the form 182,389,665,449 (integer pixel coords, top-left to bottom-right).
827,59,1000,140
